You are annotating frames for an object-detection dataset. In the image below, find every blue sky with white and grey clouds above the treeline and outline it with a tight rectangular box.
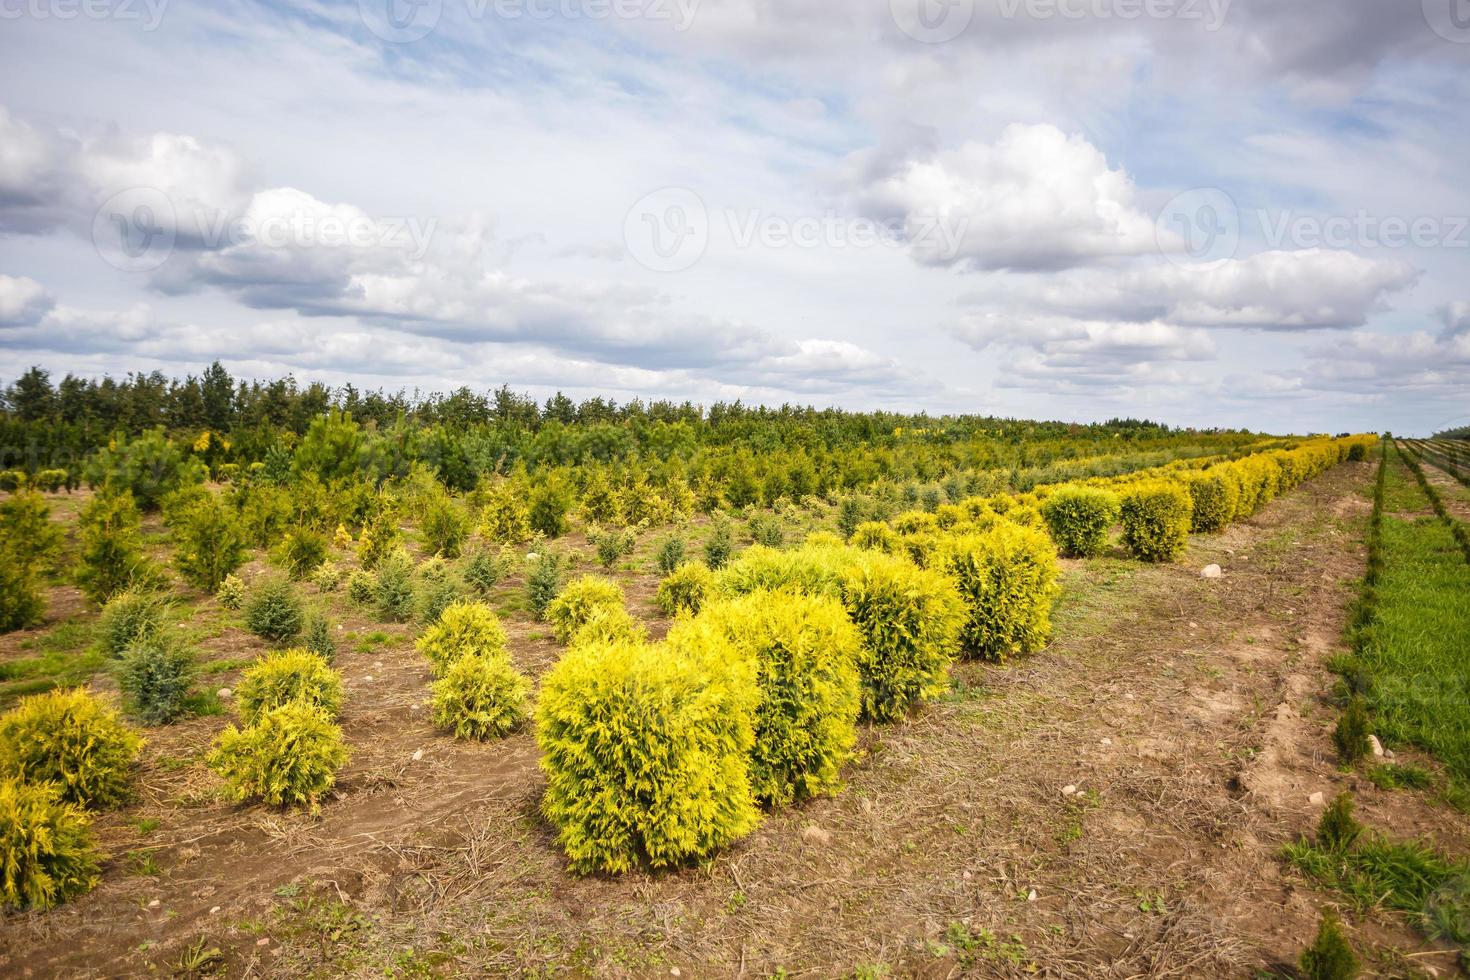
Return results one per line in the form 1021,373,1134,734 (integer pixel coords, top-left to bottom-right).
0,0,1470,435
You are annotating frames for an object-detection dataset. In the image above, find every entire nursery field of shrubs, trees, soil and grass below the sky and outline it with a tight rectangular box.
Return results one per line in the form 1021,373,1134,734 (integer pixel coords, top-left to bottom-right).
0,375,1470,977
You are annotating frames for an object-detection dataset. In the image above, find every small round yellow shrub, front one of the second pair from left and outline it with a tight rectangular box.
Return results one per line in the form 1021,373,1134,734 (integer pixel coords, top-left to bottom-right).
206,701,348,813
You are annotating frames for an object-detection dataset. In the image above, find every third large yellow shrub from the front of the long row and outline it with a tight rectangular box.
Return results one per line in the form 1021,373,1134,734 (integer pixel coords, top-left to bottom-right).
839,551,964,721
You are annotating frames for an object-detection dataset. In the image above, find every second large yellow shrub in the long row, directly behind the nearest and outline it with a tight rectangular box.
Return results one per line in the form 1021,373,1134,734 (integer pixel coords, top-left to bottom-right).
667,592,861,807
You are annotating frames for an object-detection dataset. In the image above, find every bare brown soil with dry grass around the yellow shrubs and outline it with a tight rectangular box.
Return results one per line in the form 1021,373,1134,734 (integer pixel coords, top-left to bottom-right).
0,463,1470,977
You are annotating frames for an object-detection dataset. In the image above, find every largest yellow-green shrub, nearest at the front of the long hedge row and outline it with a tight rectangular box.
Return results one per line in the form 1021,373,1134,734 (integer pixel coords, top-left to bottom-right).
537,644,760,873
